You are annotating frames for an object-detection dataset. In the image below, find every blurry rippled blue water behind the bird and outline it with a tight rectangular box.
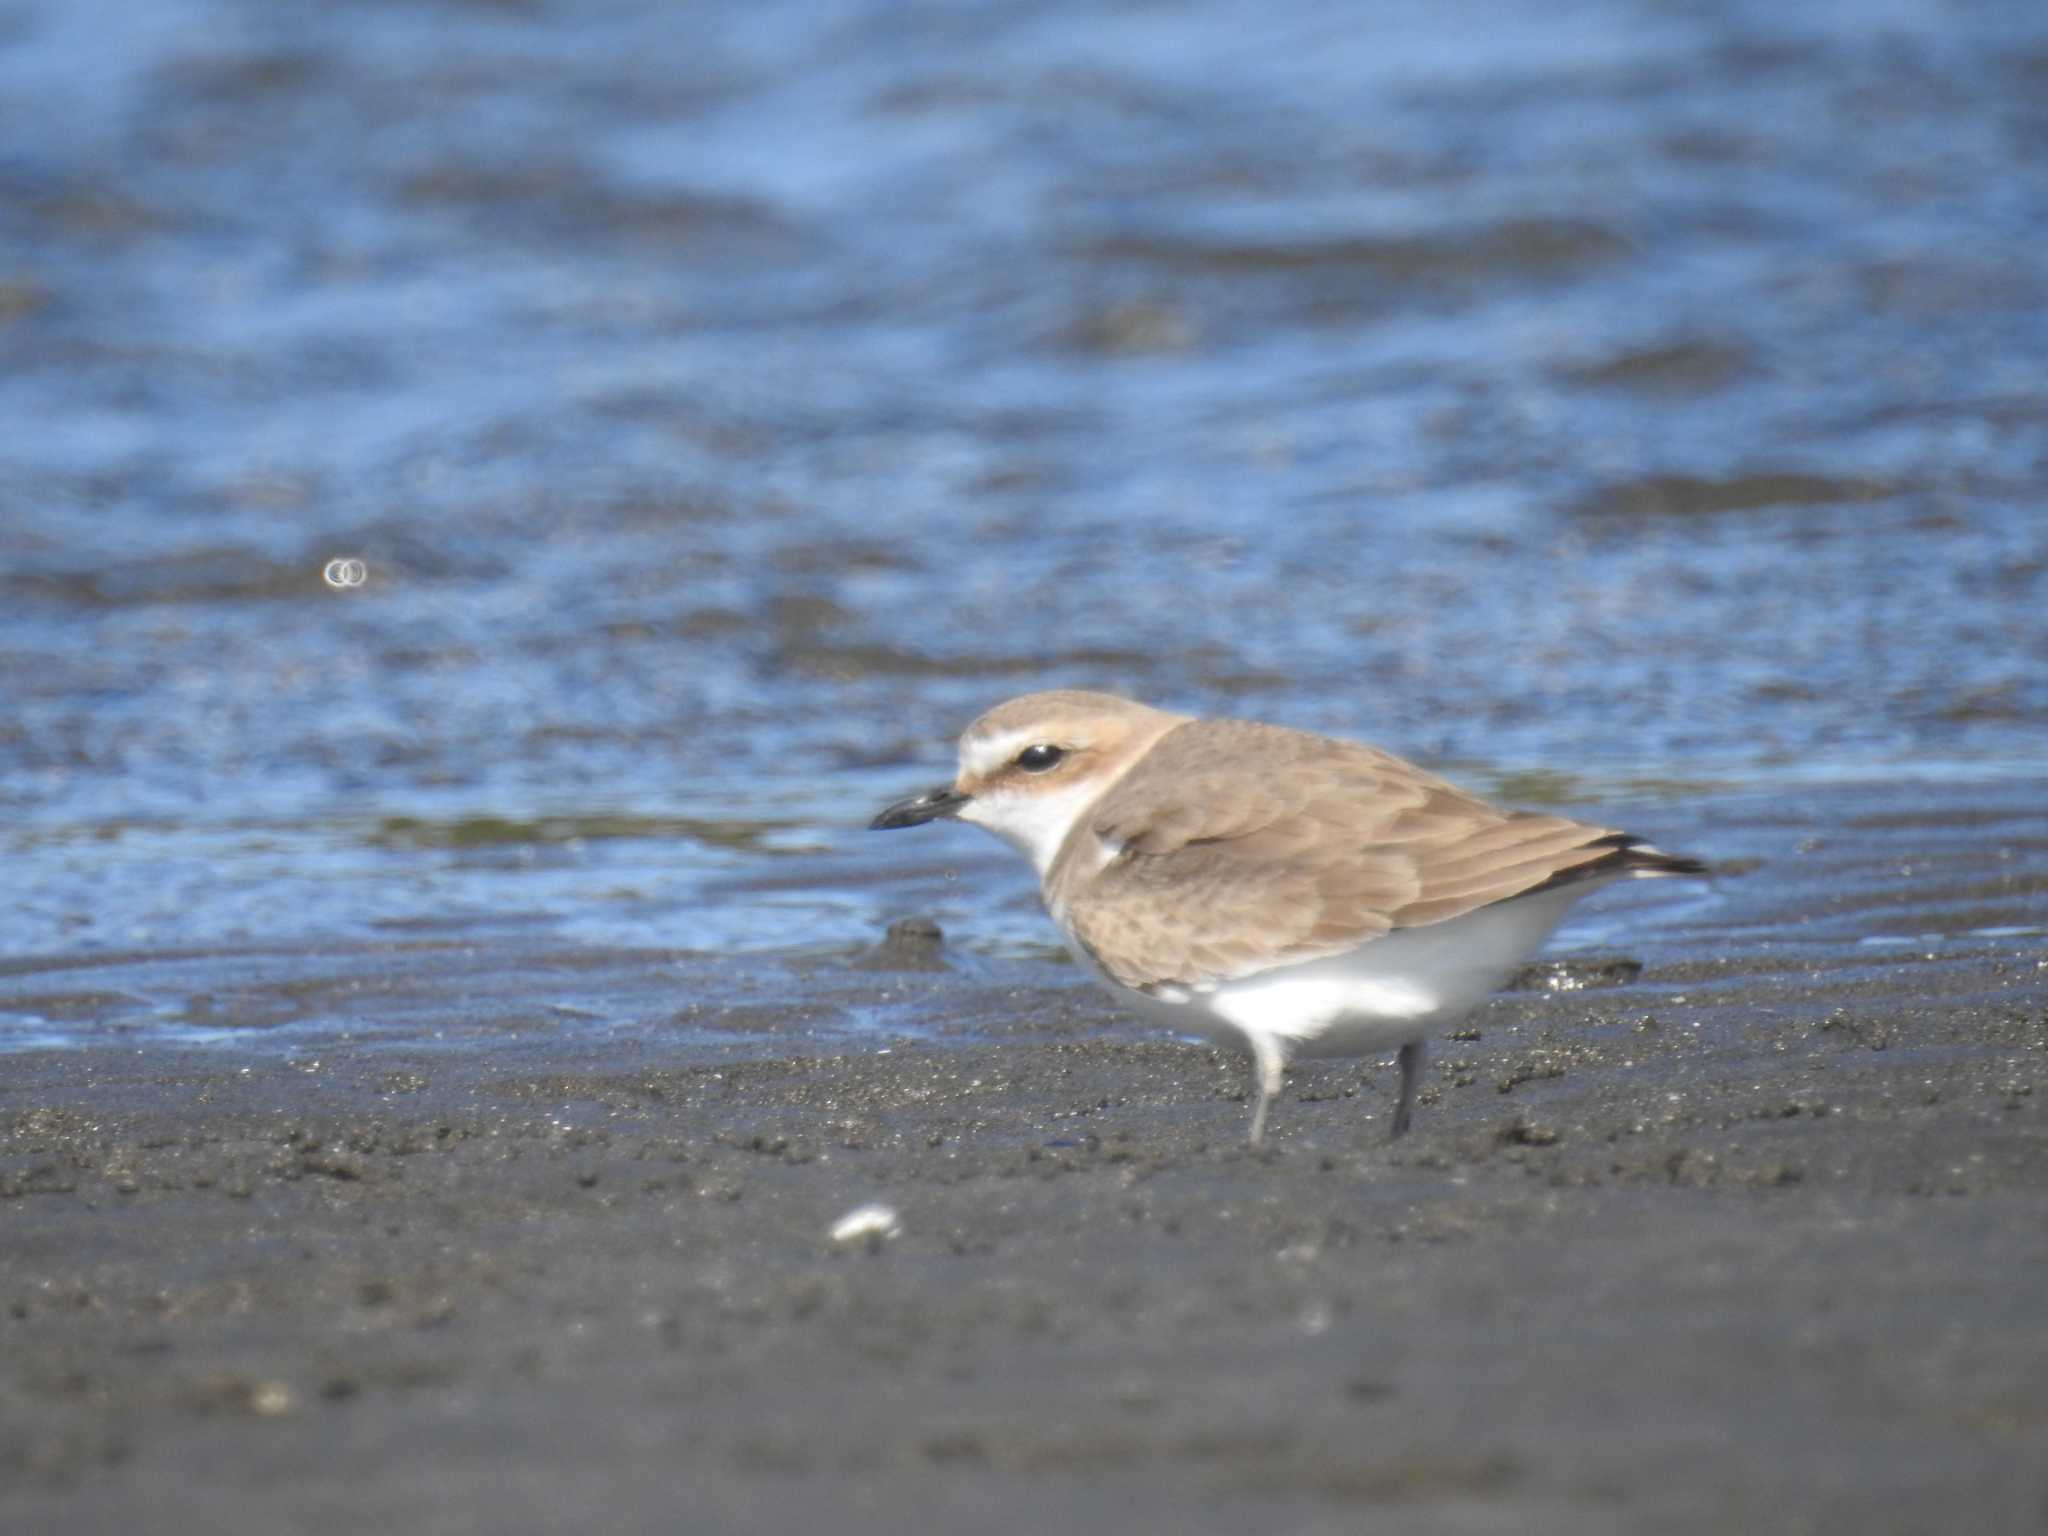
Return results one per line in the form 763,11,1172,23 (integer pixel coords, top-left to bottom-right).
0,0,2048,1044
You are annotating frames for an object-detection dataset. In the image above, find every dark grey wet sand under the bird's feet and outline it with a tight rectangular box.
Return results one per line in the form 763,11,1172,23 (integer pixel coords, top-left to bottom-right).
0,782,2048,1532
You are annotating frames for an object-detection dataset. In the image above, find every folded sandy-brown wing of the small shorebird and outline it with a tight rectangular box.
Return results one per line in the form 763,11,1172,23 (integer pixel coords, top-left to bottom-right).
1049,721,1632,987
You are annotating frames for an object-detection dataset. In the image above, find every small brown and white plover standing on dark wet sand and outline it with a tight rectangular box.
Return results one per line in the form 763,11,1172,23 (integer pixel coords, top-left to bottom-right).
868,688,1708,1145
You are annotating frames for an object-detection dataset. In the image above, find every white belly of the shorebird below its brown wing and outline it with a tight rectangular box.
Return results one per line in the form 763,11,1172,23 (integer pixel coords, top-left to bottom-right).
1077,885,1591,1057
